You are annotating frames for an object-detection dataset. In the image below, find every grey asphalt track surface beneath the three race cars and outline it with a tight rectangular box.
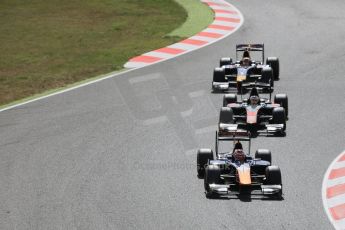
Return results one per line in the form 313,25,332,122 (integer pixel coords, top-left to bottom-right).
0,0,345,230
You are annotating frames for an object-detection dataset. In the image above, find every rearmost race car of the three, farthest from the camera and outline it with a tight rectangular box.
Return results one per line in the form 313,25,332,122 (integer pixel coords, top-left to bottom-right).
212,44,279,92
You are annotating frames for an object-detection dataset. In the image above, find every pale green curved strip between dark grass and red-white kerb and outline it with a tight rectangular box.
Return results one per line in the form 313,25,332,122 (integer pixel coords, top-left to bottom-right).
169,0,214,37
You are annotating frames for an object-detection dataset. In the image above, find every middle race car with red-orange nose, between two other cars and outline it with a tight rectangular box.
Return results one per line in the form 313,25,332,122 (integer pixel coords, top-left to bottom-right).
219,88,288,134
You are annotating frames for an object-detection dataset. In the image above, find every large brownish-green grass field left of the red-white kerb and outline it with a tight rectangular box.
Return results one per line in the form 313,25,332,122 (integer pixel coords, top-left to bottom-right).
0,0,212,107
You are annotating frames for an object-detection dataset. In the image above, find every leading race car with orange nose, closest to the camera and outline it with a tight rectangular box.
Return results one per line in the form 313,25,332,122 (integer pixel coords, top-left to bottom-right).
197,132,283,198
